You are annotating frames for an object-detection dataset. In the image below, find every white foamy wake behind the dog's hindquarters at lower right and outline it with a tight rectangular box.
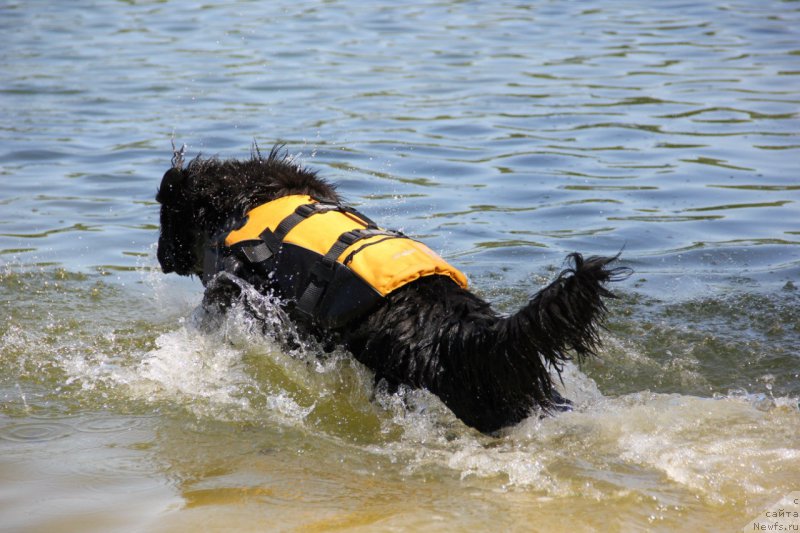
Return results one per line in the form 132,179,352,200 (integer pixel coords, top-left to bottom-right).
370,365,800,504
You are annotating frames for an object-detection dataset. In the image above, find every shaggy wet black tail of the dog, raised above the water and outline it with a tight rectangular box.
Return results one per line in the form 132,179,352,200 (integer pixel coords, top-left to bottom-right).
462,253,632,431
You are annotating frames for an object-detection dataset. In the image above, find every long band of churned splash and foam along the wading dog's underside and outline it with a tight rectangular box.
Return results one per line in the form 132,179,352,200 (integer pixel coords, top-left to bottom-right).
0,266,800,506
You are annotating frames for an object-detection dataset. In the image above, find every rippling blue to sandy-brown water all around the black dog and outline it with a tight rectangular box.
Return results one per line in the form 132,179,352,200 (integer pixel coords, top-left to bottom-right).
0,0,800,531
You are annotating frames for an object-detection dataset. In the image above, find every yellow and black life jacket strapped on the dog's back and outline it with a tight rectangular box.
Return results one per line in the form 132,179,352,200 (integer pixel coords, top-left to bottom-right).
216,195,467,327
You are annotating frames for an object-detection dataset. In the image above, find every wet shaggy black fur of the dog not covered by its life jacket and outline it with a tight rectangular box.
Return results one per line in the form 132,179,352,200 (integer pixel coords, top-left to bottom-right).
156,144,628,432
